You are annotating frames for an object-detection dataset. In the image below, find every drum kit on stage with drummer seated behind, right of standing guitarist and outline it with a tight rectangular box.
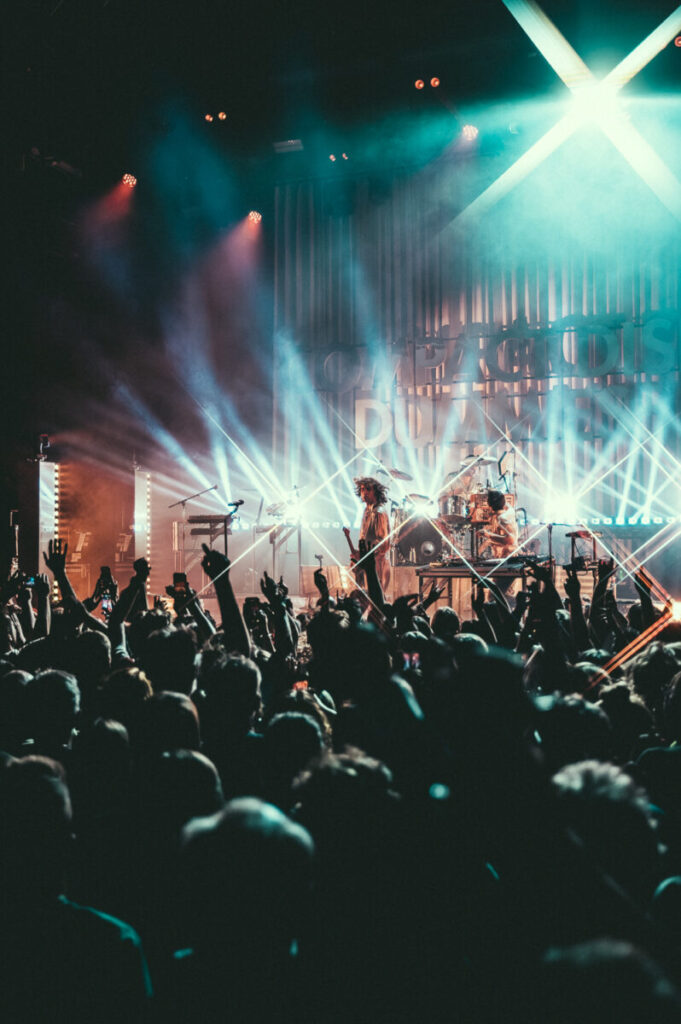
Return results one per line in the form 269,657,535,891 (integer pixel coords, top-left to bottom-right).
388,456,515,565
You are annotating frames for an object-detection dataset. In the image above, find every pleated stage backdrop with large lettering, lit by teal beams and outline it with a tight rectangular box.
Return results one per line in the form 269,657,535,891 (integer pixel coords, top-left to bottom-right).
274,155,681,522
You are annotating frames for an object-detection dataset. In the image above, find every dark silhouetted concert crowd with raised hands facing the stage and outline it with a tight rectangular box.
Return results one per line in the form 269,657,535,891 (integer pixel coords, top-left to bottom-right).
0,541,681,1024
